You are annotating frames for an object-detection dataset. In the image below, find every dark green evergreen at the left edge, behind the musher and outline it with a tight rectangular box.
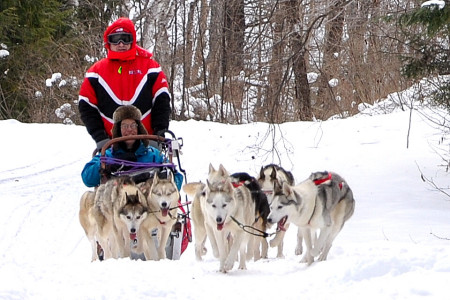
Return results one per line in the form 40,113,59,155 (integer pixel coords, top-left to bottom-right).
0,0,73,122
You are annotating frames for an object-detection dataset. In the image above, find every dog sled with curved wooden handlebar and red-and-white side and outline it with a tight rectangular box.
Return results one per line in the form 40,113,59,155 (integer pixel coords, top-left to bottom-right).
100,130,192,260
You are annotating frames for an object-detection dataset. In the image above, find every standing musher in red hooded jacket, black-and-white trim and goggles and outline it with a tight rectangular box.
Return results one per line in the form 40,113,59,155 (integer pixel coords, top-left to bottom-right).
78,18,171,149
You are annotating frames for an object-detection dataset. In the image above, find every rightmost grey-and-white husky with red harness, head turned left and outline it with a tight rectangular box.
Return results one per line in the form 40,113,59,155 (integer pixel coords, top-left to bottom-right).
268,173,355,265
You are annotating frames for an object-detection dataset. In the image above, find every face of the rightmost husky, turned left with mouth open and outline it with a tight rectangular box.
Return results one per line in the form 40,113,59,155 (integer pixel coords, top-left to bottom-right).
267,183,300,231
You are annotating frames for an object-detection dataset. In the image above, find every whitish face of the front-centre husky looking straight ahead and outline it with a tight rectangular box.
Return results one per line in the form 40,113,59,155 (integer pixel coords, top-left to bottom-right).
203,180,235,230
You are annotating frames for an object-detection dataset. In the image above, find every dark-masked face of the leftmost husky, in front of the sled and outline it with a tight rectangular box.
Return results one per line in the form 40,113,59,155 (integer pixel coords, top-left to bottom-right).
119,191,148,241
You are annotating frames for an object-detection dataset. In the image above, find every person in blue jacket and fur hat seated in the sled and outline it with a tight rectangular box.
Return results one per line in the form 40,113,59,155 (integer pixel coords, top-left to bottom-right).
81,105,183,189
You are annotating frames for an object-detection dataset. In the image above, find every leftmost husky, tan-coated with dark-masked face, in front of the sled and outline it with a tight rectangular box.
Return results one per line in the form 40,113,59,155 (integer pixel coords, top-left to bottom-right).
79,177,147,260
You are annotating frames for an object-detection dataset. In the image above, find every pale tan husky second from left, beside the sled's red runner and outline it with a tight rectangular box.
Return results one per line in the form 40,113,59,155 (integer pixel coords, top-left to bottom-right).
137,172,180,260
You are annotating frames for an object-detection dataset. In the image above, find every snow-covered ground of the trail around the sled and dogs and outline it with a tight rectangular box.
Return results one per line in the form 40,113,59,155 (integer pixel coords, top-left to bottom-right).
0,102,450,300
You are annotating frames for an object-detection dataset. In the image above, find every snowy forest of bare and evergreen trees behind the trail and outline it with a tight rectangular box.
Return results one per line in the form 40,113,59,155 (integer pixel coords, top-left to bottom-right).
0,0,450,125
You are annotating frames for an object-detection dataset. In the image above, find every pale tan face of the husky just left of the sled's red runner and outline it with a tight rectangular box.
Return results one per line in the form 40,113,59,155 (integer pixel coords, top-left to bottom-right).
149,173,180,217
